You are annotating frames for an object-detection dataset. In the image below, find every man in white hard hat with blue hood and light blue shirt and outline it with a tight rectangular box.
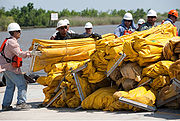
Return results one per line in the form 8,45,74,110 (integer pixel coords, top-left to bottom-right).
114,13,136,37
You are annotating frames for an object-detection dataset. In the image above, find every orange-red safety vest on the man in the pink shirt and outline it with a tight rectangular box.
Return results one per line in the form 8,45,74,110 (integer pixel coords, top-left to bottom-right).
0,38,22,68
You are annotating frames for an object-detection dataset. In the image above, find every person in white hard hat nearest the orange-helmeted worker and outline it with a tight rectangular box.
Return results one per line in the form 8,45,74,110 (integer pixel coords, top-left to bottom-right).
140,9,157,31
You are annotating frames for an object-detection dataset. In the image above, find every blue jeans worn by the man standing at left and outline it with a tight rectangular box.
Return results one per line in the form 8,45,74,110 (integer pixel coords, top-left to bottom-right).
2,71,27,106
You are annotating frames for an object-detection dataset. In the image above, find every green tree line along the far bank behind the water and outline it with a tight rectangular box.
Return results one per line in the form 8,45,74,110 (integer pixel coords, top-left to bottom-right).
0,3,180,30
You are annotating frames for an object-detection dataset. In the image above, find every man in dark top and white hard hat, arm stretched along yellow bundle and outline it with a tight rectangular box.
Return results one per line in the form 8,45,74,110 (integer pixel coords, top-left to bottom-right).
54,20,101,40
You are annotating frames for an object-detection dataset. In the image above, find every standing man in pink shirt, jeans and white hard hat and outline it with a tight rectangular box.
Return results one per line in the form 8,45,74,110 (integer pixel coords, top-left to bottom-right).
0,23,41,111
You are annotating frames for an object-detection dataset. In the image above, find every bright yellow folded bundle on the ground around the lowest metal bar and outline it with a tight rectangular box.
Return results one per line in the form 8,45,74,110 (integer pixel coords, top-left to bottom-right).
105,86,156,112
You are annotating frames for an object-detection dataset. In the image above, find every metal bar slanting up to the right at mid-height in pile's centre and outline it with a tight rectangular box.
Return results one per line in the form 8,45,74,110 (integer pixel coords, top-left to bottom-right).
107,53,126,77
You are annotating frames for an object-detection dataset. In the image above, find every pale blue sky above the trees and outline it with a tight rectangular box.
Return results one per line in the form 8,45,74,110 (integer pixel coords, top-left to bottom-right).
0,0,180,13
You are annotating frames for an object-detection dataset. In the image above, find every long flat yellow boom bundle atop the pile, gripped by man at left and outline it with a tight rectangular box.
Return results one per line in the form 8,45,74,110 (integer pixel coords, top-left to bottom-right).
29,34,117,72
